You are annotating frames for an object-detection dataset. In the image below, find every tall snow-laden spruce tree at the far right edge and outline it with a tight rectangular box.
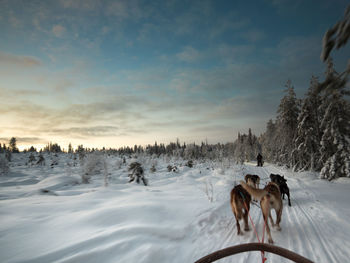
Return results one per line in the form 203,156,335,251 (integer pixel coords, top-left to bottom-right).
318,58,350,180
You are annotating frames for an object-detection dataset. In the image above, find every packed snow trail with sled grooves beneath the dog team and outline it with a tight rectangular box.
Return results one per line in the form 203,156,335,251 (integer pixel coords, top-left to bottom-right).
208,166,341,262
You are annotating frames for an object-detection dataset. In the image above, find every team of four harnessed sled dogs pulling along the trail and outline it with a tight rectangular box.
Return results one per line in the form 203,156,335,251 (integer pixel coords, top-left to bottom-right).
231,174,291,244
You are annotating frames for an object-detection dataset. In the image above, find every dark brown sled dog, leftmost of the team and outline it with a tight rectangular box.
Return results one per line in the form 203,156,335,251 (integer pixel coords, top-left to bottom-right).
231,185,251,235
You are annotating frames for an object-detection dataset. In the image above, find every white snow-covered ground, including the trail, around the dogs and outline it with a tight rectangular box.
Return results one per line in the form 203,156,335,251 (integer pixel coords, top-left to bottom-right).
0,154,350,263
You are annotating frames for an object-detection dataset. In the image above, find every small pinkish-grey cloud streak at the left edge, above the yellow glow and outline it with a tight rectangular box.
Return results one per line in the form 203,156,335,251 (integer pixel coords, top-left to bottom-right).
0,52,42,68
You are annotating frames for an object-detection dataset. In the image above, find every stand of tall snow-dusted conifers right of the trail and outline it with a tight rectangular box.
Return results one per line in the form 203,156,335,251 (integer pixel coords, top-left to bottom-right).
259,58,350,180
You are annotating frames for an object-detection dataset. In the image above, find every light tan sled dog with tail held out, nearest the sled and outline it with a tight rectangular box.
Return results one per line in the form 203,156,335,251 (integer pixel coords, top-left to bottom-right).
241,181,283,244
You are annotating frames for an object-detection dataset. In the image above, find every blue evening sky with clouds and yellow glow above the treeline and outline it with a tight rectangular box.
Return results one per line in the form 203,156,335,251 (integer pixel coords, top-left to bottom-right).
0,0,350,149
